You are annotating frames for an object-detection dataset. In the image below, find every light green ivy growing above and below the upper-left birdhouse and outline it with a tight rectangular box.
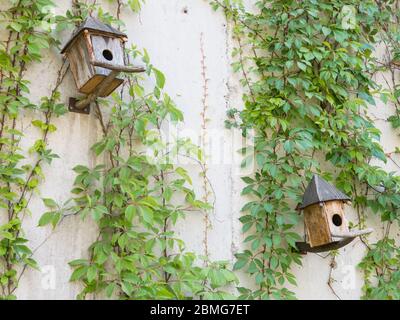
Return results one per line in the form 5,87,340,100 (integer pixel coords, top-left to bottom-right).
39,1,237,299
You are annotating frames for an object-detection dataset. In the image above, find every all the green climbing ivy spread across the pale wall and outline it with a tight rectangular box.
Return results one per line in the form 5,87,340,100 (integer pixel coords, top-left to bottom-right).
0,0,400,299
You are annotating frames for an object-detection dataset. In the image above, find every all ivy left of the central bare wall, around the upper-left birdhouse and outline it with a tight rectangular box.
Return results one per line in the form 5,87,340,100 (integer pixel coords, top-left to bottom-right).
0,0,237,299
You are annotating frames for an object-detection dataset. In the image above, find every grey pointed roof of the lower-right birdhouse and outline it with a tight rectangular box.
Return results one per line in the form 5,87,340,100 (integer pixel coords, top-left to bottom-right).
298,174,350,209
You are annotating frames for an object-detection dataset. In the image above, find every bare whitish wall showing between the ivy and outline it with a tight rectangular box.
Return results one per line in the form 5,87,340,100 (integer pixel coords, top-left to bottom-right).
2,0,400,299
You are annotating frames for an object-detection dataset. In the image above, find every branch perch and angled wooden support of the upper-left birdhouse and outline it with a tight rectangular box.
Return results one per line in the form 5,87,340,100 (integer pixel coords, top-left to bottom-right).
69,61,146,114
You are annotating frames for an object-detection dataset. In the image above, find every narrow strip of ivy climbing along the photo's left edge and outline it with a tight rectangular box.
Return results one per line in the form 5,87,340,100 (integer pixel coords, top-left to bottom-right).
0,0,65,299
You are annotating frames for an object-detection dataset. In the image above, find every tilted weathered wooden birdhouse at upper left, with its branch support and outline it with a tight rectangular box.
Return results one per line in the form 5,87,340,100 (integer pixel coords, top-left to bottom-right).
61,17,145,113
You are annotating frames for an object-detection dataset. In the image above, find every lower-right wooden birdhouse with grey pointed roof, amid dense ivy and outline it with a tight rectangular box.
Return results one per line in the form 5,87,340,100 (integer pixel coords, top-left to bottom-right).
297,175,373,252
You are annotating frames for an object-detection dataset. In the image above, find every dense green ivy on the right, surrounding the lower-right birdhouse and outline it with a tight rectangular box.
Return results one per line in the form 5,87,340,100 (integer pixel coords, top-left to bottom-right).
211,0,400,299
